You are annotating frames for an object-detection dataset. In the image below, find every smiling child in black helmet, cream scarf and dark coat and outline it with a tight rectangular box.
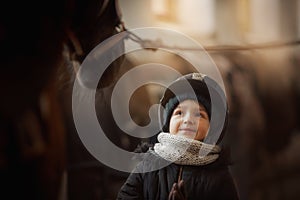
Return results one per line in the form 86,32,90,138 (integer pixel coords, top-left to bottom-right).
118,73,238,200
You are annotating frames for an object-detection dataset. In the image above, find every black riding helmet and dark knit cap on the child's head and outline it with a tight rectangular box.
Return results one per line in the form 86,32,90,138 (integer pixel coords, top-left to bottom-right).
159,73,228,144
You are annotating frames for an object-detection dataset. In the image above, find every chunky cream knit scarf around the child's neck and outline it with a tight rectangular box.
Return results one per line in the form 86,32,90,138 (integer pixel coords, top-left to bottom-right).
154,132,221,166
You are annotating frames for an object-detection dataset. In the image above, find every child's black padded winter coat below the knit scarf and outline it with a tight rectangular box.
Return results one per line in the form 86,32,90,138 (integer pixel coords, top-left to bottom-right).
117,149,239,200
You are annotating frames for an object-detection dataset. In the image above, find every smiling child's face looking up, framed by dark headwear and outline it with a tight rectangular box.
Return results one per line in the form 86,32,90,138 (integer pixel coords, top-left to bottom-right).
169,100,209,141
